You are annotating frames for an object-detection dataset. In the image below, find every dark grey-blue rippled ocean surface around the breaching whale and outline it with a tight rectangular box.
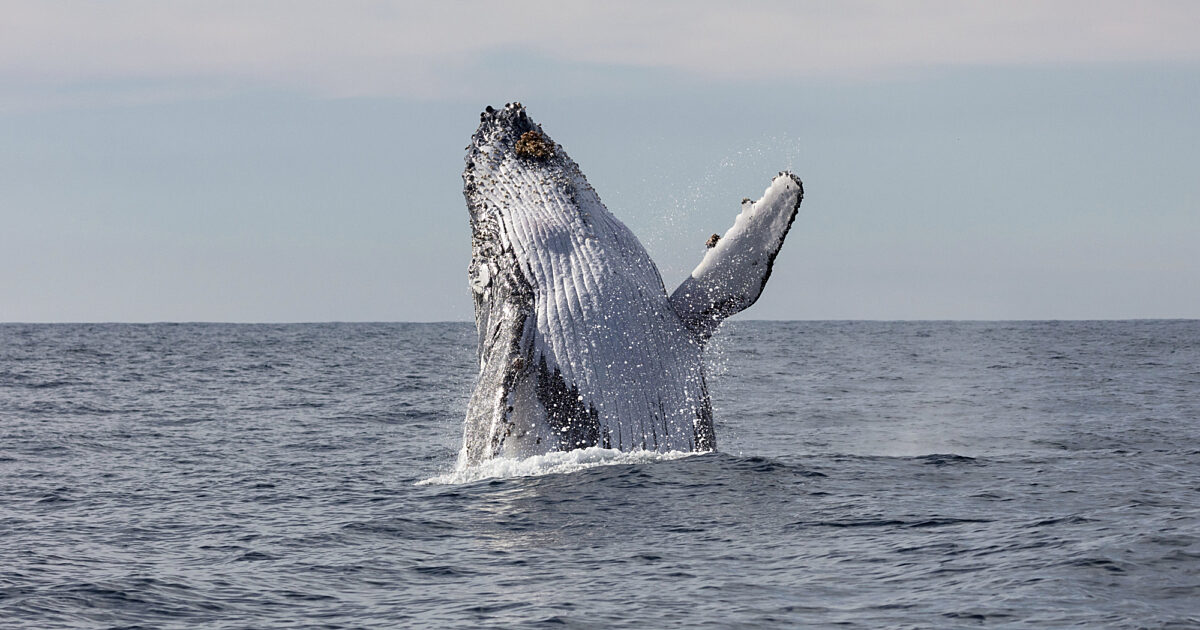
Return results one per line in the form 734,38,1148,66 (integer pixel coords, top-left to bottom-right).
0,320,1200,630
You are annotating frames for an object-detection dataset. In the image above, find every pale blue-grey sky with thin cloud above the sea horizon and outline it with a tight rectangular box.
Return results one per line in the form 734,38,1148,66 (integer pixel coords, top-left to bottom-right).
0,0,1200,322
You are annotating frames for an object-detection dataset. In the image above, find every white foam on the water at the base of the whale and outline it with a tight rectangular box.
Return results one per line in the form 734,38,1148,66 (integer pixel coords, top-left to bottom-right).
416,446,698,486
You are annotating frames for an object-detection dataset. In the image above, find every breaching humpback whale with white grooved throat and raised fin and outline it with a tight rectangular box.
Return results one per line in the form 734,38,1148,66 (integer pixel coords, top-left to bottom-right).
460,103,804,466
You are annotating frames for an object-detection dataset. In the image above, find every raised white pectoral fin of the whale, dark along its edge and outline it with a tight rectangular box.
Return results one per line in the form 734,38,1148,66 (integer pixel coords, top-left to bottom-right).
671,172,804,341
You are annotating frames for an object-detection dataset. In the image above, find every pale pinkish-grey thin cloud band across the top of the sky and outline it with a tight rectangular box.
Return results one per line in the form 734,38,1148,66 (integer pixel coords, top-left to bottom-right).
0,0,1200,100
